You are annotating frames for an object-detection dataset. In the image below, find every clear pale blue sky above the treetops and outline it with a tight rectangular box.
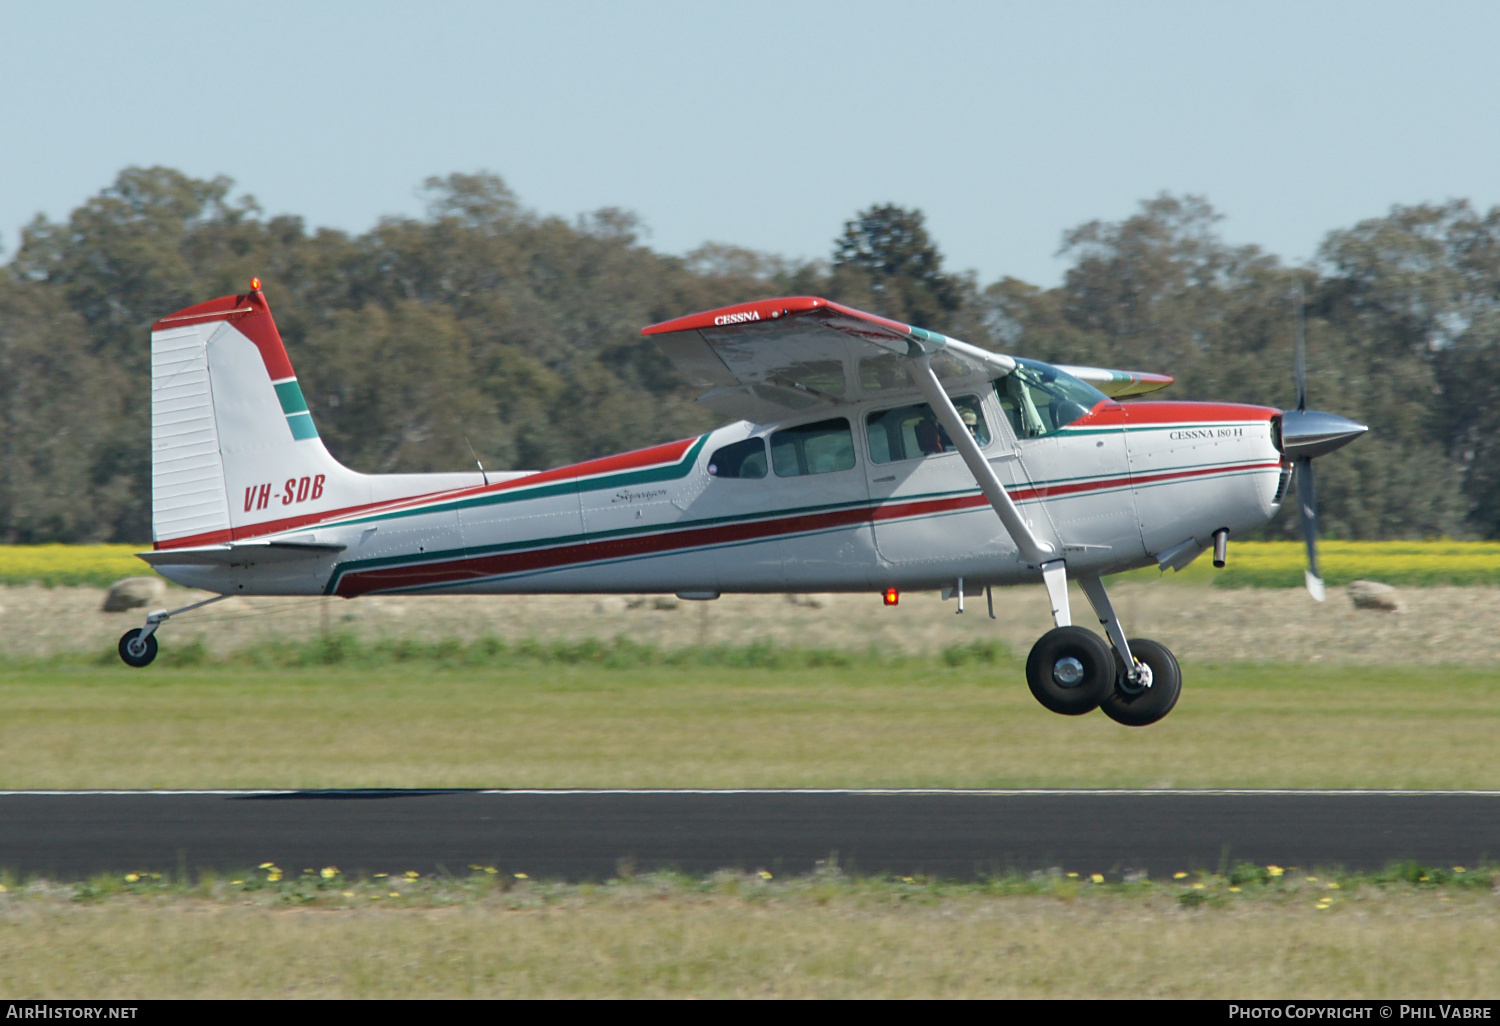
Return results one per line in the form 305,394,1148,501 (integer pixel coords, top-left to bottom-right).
0,0,1500,285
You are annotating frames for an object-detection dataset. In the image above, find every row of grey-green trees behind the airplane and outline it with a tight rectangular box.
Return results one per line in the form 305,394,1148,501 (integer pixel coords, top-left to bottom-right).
0,168,1500,543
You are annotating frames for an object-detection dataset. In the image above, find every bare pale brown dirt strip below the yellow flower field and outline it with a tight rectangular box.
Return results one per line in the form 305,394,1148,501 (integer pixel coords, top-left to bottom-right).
0,581,1500,663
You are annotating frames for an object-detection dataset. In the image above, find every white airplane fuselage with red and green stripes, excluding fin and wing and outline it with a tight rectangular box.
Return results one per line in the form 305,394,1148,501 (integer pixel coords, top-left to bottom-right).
153,381,1287,597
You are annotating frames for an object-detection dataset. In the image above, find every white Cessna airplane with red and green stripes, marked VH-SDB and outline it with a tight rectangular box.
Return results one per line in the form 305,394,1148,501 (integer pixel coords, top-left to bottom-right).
129,281,1365,725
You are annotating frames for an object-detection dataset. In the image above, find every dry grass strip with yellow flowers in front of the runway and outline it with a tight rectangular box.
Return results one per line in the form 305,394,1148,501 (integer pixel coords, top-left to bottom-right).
0,866,1500,999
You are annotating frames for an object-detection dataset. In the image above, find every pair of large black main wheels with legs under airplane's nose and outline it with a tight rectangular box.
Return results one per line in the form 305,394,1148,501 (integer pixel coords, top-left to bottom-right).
1026,560,1182,726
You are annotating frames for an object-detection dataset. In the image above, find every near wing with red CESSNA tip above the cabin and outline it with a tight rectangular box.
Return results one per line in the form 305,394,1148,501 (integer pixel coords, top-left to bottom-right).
642,296,1016,423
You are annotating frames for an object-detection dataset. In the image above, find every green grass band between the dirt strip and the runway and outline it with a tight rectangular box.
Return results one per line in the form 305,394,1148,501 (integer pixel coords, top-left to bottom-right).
0,638,1500,789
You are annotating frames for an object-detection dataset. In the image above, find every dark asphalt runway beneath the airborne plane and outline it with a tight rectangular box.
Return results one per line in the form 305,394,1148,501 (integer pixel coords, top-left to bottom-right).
0,791,1500,881
